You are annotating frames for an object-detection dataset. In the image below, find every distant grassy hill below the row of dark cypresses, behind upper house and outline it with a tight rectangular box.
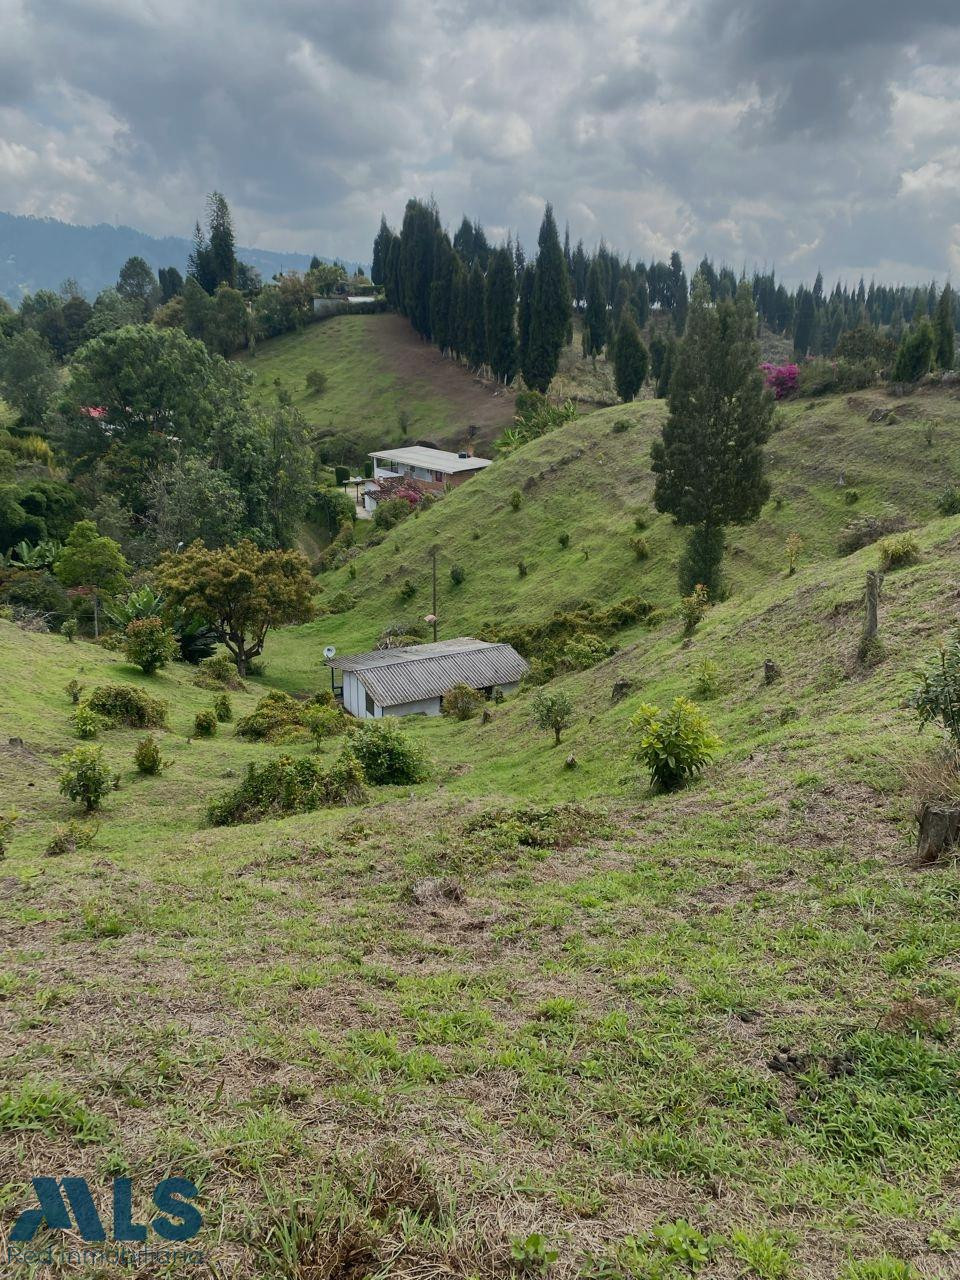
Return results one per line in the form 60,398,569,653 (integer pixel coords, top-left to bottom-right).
239,315,512,461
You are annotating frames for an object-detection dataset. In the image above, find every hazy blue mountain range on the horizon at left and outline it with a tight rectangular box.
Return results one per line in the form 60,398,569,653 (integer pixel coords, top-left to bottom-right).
0,212,357,306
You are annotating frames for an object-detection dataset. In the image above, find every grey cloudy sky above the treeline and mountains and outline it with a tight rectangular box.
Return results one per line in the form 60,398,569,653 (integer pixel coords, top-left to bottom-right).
0,0,960,280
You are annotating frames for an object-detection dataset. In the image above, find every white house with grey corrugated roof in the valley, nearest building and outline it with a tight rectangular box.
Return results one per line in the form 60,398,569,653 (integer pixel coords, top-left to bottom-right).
329,636,530,719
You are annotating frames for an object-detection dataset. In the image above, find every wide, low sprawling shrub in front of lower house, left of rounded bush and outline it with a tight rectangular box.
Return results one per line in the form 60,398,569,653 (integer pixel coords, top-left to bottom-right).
207,748,366,827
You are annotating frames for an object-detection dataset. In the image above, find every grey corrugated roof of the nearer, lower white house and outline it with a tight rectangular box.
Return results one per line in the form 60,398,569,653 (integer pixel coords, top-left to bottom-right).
330,636,529,707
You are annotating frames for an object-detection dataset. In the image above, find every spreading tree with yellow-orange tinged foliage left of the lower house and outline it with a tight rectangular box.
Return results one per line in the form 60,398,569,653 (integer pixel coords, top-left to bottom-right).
157,539,314,676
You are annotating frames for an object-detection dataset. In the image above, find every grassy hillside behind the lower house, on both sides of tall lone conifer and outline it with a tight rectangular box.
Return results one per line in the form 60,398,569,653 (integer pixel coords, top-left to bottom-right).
269,378,960,684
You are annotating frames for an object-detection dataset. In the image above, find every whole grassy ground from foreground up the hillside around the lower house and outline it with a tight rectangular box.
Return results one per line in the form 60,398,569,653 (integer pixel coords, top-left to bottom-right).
0,384,960,1280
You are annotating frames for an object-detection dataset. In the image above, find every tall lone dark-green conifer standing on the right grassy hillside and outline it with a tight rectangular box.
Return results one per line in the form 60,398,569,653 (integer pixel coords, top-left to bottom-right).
652,282,773,596
